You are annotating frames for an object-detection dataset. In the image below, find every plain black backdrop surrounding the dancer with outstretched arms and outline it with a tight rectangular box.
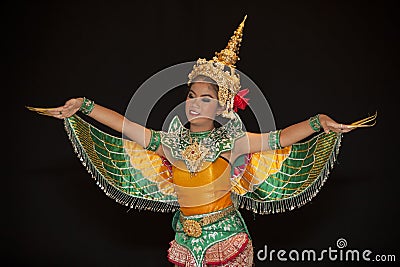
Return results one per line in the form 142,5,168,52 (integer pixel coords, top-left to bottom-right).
1,1,400,266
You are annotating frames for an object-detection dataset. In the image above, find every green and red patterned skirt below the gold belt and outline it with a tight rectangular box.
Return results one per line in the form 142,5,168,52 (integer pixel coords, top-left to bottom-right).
168,210,253,267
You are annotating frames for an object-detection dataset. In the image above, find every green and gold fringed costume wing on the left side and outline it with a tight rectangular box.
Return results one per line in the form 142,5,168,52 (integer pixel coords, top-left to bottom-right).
64,115,179,212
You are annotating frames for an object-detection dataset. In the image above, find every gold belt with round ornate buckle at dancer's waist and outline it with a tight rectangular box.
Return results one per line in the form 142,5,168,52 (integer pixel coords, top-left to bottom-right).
179,206,235,237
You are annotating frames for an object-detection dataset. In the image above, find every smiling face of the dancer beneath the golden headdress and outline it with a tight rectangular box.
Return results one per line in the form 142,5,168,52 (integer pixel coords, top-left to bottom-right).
185,82,222,125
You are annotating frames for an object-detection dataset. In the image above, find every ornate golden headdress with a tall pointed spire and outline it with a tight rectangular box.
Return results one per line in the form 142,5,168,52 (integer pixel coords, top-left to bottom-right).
188,16,247,118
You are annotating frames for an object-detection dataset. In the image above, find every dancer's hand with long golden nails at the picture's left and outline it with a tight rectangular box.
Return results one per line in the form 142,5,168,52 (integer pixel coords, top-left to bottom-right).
27,97,83,119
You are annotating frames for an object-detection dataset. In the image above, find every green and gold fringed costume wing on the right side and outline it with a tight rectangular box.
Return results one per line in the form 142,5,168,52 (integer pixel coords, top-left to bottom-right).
232,132,342,214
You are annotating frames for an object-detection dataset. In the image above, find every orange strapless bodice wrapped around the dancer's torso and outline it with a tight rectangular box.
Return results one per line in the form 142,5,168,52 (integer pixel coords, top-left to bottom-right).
172,158,232,215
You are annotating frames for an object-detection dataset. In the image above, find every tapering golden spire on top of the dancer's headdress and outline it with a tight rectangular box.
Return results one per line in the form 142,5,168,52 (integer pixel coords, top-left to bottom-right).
213,15,247,68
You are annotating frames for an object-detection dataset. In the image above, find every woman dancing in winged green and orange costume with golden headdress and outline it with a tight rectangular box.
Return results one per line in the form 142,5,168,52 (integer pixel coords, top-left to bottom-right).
31,16,376,266
